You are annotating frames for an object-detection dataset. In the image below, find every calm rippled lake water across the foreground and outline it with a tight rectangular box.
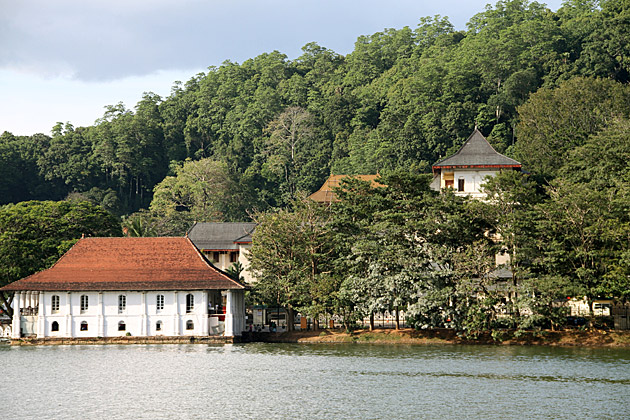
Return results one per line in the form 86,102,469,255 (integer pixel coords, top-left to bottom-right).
0,344,630,420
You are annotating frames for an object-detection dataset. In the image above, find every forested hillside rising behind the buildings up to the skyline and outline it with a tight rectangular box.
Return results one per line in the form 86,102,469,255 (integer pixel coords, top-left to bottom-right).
0,0,630,230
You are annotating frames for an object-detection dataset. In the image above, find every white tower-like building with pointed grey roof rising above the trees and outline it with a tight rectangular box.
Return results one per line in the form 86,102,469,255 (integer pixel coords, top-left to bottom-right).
431,127,521,198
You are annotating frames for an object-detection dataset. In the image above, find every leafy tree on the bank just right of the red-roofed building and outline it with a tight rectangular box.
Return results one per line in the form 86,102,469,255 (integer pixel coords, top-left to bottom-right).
249,196,337,330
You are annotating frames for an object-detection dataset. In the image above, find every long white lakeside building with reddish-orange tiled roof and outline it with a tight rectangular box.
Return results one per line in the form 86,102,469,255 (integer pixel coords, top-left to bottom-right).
0,238,246,338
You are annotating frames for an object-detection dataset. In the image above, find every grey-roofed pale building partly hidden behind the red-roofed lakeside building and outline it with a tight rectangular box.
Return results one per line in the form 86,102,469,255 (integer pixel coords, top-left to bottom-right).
187,223,256,283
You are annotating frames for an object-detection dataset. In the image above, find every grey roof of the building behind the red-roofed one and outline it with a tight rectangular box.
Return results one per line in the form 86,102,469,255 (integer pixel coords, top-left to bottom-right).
187,223,256,251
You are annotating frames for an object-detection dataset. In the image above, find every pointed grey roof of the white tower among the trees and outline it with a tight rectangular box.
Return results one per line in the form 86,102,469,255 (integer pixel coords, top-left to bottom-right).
433,127,521,171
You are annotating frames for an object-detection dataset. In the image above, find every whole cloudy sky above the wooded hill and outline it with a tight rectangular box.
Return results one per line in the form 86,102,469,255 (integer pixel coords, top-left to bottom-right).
0,0,562,135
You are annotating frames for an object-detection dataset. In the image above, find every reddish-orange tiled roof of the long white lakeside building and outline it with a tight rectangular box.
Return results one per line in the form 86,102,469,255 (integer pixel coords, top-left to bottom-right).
0,238,245,291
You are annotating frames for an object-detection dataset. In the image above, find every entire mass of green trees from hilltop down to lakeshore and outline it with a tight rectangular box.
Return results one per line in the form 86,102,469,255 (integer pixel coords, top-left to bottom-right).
0,0,630,333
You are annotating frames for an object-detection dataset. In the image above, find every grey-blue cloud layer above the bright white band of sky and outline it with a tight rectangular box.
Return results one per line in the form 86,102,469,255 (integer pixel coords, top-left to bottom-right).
0,0,559,81
